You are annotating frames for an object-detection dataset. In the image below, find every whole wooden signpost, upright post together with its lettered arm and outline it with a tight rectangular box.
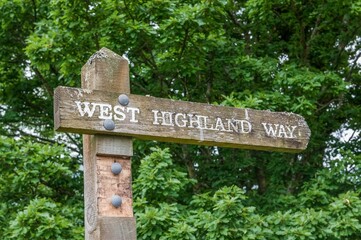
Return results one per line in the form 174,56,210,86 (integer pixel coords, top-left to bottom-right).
54,48,310,240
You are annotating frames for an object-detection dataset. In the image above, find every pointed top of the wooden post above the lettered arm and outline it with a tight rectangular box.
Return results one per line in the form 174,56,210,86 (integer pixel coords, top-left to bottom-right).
81,48,130,93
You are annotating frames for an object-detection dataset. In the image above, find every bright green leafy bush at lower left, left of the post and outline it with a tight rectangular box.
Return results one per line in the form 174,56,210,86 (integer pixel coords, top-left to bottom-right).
0,137,83,239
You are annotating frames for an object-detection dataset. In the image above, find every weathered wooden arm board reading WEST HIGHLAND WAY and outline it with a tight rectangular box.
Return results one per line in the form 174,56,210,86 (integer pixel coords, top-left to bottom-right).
54,87,310,152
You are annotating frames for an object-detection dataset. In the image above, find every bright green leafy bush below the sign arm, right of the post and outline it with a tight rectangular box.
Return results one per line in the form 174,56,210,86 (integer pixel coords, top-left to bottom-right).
135,148,361,240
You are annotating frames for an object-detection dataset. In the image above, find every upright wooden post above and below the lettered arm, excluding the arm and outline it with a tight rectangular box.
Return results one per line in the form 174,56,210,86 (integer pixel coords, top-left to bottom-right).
82,48,136,240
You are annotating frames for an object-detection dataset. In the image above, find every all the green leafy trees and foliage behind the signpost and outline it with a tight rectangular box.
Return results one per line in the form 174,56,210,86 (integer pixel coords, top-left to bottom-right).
0,0,361,239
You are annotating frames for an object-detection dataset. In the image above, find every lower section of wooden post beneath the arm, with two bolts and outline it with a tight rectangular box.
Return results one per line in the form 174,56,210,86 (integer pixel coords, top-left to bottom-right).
83,135,136,240
